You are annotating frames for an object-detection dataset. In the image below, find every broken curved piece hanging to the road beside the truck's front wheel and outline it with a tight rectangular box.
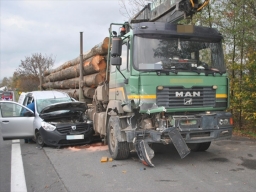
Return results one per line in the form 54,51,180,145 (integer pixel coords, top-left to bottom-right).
135,140,154,167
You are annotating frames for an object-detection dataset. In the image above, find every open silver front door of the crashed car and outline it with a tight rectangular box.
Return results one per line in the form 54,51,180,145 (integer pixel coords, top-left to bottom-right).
0,101,35,140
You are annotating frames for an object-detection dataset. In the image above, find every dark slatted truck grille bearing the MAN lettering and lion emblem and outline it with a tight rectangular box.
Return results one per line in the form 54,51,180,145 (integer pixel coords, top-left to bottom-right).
156,86,216,108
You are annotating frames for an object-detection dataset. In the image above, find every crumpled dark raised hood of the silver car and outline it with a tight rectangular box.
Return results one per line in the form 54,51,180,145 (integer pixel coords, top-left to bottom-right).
39,102,87,119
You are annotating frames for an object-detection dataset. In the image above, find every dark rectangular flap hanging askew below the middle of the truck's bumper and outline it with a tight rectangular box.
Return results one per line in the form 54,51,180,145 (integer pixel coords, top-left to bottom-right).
164,128,190,159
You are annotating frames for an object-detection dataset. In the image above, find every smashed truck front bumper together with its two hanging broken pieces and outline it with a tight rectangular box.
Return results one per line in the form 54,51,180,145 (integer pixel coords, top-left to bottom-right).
123,112,233,167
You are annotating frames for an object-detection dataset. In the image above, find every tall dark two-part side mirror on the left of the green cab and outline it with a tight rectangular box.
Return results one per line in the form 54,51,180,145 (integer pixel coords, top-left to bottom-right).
110,37,123,66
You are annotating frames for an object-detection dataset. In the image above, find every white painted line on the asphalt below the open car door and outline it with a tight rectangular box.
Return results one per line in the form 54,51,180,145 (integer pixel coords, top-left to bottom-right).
11,140,27,192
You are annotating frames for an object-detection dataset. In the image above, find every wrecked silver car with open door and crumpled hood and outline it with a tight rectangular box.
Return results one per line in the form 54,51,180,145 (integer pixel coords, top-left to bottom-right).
0,91,94,147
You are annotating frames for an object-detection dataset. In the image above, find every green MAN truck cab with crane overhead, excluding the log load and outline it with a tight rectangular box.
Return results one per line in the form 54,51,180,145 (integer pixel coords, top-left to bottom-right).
87,0,233,167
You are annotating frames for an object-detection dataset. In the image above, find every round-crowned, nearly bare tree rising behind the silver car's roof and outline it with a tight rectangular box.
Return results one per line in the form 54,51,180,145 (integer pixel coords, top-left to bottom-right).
17,53,55,90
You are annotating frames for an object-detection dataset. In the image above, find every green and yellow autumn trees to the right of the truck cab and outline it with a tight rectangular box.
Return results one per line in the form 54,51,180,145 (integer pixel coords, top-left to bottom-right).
185,0,256,132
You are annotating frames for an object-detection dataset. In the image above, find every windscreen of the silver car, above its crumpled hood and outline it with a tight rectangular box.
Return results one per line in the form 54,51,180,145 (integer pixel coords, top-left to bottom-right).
36,97,72,113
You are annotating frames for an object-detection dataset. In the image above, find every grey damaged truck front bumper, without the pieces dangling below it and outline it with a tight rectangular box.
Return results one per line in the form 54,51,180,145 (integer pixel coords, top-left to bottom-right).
124,112,233,144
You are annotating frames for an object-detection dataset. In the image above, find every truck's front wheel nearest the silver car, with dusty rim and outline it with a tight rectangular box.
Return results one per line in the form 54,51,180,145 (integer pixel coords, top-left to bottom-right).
107,116,130,160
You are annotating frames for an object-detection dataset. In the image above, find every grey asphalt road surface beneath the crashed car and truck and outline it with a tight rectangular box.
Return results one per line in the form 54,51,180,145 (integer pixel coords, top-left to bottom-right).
0,137,256,192
